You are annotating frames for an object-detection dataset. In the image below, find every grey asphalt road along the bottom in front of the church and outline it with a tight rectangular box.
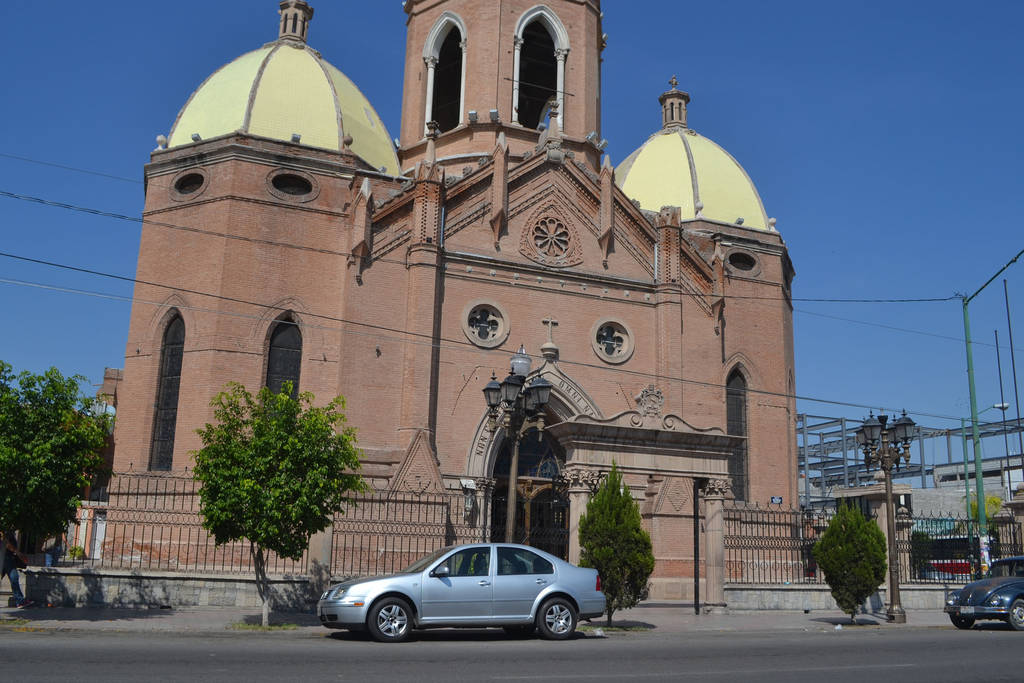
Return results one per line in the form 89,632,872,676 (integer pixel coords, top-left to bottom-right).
0,625,1024,683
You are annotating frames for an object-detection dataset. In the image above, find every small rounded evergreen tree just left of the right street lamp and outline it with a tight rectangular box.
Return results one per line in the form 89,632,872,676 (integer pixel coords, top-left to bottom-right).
814,503,886,622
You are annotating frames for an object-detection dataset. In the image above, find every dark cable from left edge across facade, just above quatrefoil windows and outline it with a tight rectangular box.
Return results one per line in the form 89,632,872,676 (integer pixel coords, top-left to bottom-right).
0,189,959,303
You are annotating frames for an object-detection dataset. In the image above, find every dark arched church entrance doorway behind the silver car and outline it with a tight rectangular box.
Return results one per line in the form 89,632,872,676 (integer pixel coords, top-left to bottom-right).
490,429,569,558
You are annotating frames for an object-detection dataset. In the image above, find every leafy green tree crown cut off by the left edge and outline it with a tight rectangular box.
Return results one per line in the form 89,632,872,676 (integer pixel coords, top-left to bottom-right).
0,360,113,539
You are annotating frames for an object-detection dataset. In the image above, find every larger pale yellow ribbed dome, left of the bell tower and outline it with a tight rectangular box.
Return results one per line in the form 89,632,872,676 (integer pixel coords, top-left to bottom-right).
167,1,399,175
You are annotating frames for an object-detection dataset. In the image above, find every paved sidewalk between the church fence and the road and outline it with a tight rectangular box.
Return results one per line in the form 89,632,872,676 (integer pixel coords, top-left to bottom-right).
0,602,953,636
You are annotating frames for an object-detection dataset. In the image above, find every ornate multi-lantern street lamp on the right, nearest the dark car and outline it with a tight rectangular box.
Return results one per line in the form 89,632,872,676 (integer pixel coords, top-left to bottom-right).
856,411,914,624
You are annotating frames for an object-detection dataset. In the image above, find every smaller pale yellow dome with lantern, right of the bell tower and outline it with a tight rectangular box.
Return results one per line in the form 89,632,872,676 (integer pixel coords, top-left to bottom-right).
615,78,772,230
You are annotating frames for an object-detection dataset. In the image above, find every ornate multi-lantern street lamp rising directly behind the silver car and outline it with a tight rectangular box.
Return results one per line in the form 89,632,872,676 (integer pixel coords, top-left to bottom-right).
483,345,552,543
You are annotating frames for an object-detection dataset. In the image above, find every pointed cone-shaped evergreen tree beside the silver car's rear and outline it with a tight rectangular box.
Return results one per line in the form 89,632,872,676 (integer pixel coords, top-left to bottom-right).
580,463,654,626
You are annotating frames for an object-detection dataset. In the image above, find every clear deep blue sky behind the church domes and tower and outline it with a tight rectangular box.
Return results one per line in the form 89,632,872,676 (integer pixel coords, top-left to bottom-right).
0,0,1024,458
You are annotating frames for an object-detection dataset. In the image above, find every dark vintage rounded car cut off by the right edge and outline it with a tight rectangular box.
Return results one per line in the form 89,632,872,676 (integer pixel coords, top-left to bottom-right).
945,557,1024,631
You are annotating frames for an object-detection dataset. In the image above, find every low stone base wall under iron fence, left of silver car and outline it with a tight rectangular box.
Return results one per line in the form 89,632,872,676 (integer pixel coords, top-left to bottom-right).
22,567,319,611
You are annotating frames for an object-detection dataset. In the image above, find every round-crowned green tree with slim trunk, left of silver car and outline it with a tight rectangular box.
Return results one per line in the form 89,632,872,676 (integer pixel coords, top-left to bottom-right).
193,382,367,626
